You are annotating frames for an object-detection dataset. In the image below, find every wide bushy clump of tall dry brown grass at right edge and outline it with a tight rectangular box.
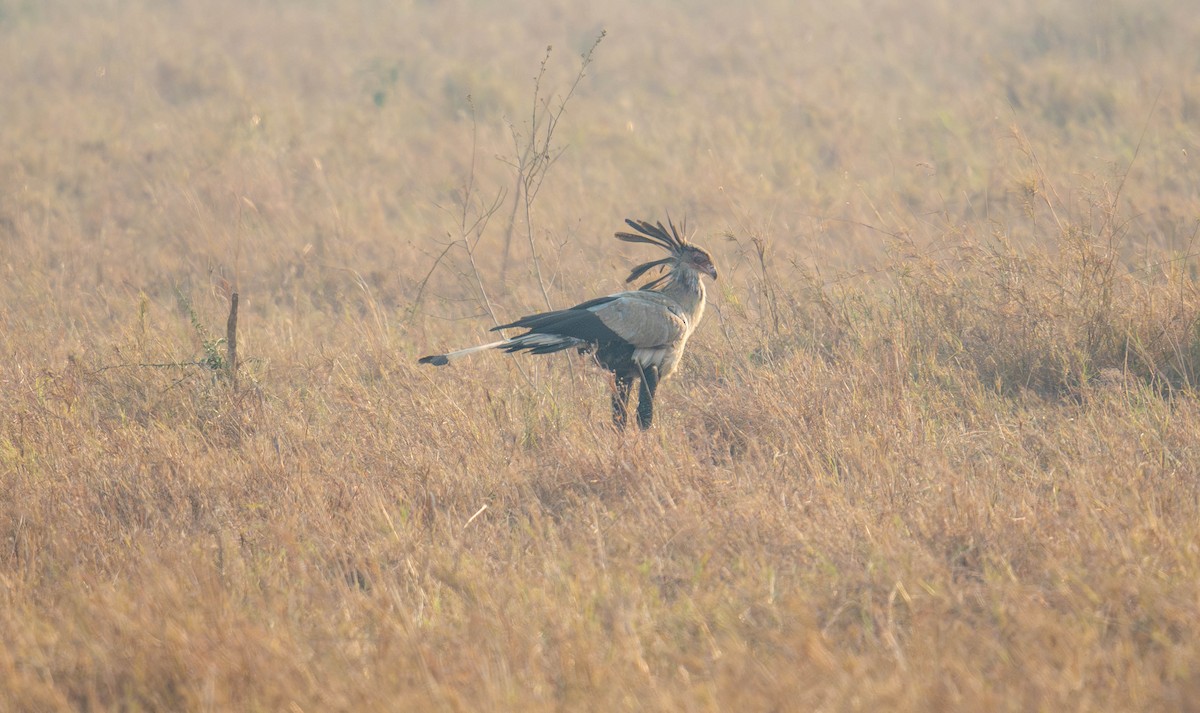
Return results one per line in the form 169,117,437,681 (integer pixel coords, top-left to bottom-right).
895,222,1200,397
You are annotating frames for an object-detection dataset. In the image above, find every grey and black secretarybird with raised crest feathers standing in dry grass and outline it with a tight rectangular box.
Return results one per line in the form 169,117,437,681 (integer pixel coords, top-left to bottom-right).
420,218,716,430
